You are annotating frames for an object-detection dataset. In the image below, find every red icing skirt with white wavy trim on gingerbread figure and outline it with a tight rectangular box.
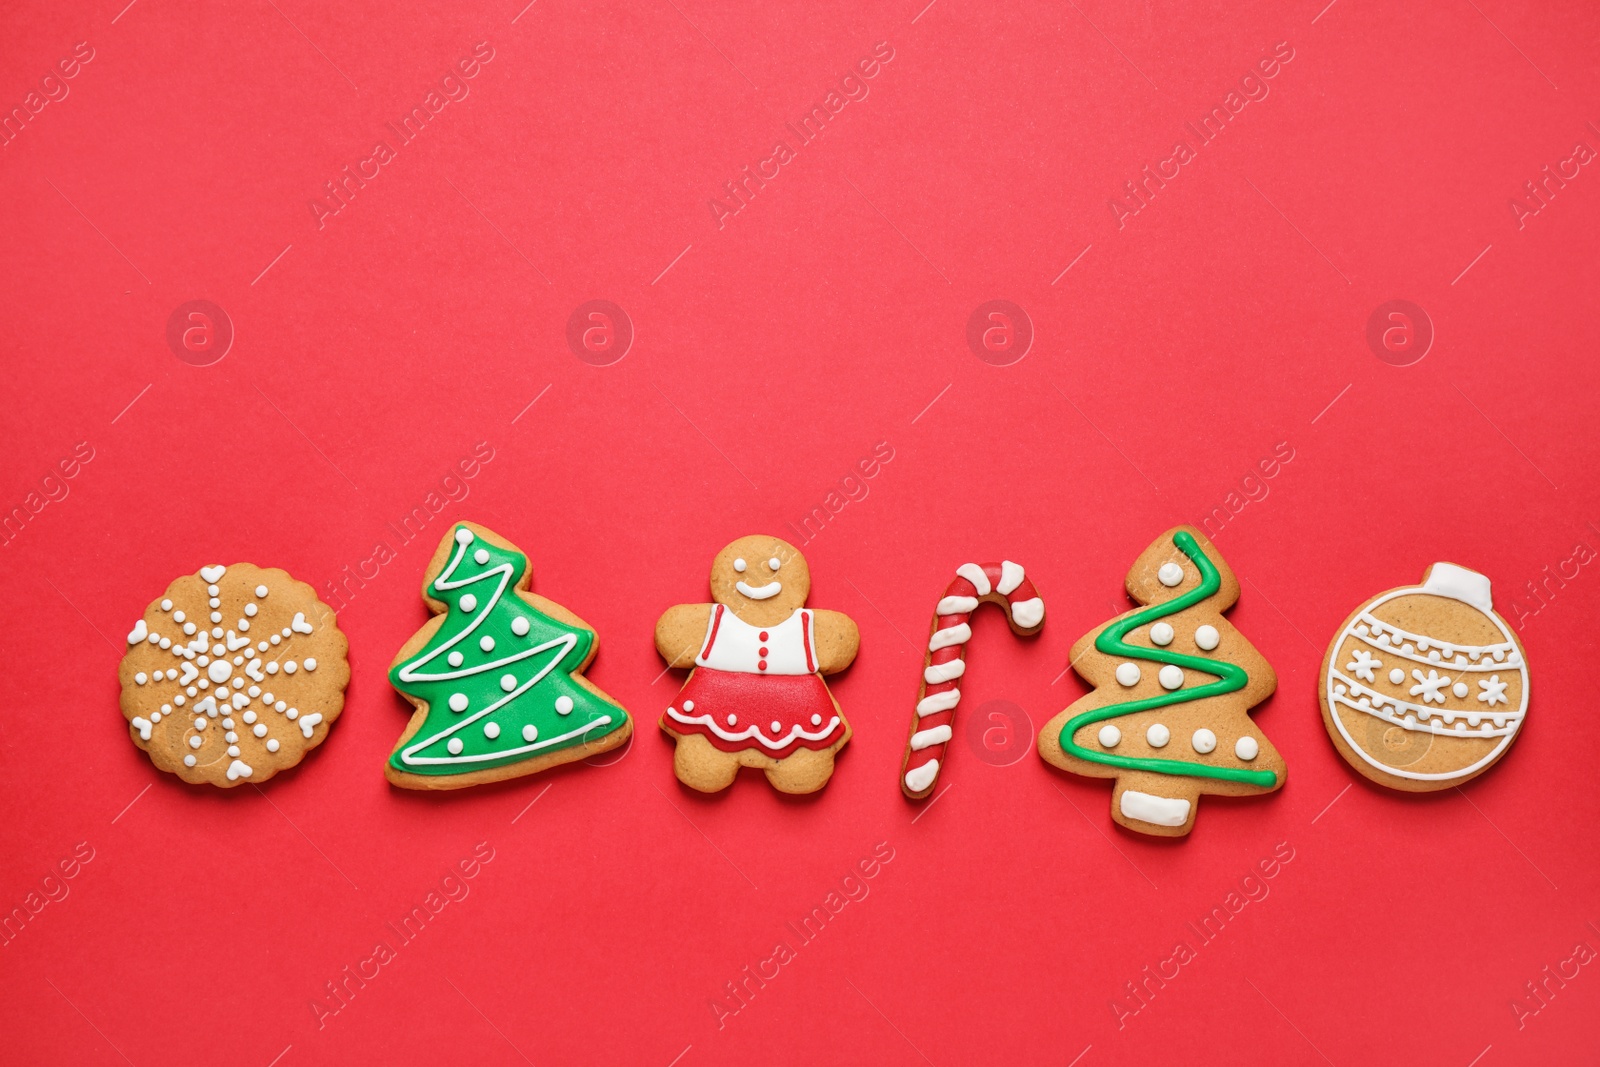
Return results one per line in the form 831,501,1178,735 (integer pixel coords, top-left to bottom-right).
661,667,845,760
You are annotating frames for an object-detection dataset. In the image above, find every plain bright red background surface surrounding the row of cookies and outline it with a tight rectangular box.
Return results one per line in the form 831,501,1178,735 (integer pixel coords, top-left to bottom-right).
0,0,1600,1067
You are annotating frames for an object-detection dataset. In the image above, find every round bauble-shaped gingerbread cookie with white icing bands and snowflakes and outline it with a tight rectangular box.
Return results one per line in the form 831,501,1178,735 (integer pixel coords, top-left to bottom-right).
1320,563,1528,792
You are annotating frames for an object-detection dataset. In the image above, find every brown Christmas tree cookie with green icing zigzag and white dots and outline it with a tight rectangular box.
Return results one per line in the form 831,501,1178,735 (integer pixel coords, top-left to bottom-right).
1038,526,1285,837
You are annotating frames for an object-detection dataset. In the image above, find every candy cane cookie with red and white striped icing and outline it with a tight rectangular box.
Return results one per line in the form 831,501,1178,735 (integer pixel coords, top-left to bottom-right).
901,560,1045,800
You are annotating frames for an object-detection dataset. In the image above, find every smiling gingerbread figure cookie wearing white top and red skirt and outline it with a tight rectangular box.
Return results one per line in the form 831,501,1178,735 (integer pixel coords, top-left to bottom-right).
656,536,861,793
